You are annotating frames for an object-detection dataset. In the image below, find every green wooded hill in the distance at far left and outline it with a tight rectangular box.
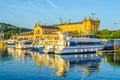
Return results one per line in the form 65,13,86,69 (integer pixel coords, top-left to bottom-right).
0,23,32,39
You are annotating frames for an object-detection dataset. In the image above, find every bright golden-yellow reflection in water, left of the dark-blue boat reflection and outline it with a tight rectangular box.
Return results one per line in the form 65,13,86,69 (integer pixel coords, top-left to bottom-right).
31,53,69,76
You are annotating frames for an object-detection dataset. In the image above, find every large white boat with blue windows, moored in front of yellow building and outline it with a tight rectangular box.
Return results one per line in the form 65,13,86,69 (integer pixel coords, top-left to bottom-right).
54,33,104,54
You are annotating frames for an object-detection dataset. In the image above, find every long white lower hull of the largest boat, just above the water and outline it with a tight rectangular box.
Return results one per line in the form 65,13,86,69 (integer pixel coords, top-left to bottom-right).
55,45,104,54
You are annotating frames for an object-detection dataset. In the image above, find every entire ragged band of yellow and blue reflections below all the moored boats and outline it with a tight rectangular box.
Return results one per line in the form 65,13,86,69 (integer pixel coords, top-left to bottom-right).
0,48,103,78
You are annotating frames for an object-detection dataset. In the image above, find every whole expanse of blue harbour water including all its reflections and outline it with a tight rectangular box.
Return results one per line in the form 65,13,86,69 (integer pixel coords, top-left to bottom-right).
0,48,120,80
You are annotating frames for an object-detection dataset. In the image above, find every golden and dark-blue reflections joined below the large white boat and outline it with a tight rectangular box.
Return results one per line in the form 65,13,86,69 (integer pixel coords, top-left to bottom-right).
31,53,102,77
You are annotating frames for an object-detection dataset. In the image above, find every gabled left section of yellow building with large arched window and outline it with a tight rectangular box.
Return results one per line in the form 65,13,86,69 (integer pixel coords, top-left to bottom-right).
34,24,60,39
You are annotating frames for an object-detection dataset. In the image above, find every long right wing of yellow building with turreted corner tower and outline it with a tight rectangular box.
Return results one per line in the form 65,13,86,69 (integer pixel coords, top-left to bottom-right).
56,17,100,34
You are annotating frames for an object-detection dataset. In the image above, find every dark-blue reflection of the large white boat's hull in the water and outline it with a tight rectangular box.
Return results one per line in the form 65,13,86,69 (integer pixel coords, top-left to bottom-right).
62,54,103,74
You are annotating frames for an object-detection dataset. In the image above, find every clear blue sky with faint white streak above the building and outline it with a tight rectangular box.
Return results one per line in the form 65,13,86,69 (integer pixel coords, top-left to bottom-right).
0,0,120,30
